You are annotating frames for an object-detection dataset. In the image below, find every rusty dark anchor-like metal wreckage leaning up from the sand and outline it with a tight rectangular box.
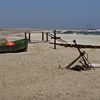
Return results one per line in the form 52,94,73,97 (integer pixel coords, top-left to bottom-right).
65,40,95,71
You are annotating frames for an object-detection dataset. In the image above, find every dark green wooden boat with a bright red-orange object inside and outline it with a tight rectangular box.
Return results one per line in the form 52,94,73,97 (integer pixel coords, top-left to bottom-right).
0,39,28,53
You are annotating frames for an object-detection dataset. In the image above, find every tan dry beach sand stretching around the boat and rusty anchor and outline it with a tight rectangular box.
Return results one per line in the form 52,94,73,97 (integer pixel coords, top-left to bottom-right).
0,34,100,100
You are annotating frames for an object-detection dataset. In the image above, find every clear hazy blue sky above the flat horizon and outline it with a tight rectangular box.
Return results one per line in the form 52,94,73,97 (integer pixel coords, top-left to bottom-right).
0,0,100,28
